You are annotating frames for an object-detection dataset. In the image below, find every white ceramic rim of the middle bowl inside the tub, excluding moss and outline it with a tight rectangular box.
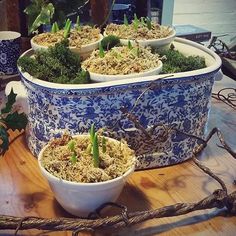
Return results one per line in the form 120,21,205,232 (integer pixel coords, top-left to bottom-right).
89,60,163,82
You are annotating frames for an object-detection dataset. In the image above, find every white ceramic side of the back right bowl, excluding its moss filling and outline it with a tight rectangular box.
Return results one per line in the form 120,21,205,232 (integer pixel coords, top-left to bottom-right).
104,28,176,48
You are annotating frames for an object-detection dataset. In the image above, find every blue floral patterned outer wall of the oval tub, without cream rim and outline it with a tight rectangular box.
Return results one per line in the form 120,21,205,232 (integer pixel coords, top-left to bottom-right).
22,71,214,168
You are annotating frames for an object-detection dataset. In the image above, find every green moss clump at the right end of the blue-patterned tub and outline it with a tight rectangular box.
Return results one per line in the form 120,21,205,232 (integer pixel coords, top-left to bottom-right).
158,46,206,74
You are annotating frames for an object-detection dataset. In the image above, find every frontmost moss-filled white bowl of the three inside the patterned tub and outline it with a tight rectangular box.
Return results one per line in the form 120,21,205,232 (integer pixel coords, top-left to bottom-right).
82,45,162,82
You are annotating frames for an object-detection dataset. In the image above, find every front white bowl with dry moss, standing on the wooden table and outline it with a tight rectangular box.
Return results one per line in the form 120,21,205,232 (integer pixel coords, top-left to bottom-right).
38,132,135,217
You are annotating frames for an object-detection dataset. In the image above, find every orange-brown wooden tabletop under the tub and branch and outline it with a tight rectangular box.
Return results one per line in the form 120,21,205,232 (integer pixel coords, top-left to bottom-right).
0,74,236,236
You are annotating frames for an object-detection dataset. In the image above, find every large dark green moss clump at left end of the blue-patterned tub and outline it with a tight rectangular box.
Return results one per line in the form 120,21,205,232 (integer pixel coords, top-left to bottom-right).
18,39,90,84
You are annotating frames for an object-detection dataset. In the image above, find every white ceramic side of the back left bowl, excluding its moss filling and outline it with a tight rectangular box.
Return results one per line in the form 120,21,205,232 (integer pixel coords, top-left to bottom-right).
30,34,103,60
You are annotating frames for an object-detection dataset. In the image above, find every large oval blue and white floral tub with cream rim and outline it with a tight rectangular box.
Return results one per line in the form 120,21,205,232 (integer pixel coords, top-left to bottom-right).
9,38,221,169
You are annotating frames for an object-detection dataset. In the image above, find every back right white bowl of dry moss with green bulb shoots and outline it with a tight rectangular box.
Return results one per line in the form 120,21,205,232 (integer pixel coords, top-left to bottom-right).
104,14,176,48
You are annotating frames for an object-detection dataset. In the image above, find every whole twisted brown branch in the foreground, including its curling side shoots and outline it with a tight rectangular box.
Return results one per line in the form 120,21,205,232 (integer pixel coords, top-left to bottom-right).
0,128,236,235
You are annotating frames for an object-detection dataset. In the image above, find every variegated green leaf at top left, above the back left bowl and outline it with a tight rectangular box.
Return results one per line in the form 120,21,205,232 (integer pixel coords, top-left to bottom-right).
24,0,55,34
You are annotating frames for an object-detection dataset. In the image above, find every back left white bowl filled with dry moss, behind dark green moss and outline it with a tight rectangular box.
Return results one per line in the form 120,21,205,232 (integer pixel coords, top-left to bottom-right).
30,26,103,59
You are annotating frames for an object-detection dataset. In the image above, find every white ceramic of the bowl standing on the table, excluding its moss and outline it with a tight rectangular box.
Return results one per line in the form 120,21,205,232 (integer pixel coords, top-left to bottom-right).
38,135,135,217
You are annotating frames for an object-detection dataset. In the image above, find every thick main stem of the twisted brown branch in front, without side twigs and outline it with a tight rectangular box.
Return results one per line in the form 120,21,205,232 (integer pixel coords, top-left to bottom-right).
0,189,236,232
